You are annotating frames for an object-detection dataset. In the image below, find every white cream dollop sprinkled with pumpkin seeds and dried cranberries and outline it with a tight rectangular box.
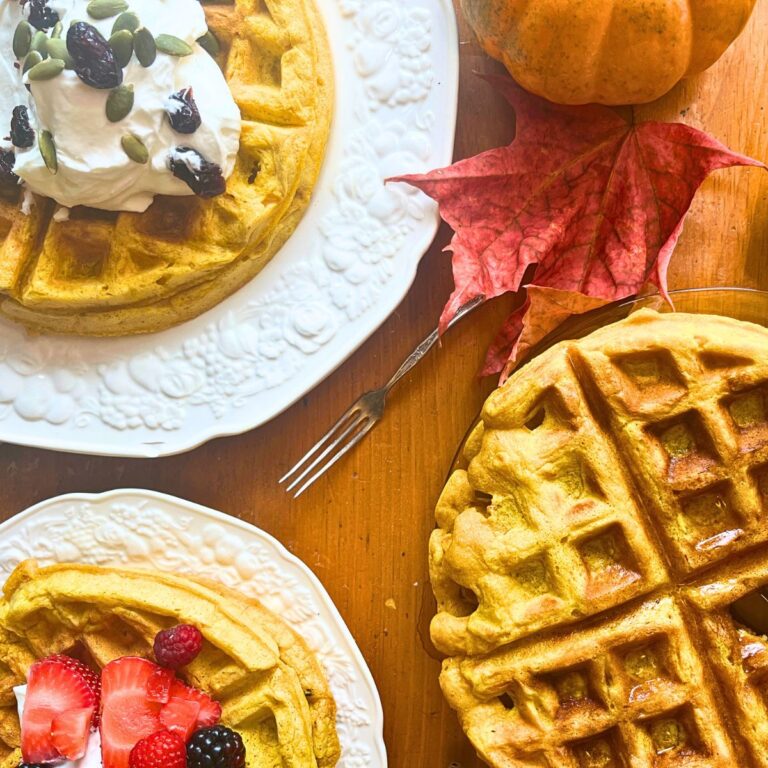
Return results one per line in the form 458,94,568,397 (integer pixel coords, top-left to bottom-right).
0,0,241,212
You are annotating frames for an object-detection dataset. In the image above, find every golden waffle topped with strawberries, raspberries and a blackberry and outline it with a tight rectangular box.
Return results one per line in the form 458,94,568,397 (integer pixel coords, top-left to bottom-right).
0,561,340,768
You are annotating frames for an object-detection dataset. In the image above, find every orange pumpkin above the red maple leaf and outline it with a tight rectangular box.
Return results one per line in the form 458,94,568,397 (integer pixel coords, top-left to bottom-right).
461,0,756,104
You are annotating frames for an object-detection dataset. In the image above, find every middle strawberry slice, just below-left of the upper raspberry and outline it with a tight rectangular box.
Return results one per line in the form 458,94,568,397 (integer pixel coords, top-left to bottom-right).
101,656,163,768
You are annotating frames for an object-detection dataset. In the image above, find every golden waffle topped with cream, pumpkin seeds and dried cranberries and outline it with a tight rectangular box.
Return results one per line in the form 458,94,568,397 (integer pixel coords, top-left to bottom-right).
0,0,333,336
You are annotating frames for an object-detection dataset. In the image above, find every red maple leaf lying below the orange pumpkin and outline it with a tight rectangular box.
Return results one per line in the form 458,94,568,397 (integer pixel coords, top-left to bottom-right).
392,77,765,375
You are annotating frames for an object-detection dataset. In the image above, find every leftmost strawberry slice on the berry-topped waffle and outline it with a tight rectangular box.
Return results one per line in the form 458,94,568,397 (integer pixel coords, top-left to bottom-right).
21,656,99,763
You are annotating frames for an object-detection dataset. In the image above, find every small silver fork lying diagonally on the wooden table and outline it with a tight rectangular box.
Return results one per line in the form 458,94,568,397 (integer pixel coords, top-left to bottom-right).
279,296,484,499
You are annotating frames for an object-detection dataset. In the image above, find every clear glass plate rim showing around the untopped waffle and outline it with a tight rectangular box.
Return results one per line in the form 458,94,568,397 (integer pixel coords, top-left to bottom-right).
451,287,768,472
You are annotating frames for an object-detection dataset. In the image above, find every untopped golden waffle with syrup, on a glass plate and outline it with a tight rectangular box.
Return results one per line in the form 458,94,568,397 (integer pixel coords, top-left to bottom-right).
430,310,768,768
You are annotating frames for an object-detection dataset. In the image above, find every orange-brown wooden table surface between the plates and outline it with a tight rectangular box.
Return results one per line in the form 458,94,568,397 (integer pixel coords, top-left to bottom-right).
0,0,768,768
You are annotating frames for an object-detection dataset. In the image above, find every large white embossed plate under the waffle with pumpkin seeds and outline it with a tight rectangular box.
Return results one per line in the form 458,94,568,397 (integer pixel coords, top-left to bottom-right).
0,0,458,456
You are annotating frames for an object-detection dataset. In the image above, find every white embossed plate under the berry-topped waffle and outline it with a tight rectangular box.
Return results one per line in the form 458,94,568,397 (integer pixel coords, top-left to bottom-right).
0,488,387,768
